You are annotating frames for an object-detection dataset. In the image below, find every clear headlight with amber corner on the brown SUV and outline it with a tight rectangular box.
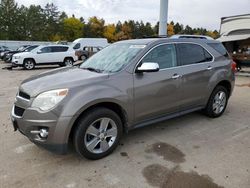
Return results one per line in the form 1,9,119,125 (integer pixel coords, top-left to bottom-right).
31,89,68,111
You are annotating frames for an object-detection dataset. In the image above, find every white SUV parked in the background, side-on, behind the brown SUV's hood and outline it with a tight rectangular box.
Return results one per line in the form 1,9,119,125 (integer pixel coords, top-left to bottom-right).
12,45,77,70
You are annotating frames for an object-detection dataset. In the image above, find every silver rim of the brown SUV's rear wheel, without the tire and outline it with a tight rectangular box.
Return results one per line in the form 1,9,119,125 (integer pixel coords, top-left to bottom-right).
213,91,227,114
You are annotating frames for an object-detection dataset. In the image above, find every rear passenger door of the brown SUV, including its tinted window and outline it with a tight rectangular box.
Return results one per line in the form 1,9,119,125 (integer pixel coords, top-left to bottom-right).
176,43,214,110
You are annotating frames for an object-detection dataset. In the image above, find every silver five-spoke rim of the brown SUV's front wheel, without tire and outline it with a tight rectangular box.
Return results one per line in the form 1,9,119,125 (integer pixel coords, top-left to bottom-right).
84,118,117,154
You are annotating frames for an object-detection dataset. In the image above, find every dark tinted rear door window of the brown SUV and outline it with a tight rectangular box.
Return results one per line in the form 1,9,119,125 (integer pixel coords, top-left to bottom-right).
177,44,213,65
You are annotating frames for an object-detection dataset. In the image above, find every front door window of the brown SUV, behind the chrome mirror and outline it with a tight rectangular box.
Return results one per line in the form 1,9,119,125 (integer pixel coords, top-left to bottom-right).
142,44,177,69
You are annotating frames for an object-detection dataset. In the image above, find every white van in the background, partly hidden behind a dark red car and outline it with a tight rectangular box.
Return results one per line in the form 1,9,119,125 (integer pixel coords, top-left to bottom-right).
71,38,109,50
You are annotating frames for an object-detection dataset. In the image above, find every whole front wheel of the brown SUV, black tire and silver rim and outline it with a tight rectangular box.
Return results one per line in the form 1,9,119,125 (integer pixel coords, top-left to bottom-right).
73,108,123,160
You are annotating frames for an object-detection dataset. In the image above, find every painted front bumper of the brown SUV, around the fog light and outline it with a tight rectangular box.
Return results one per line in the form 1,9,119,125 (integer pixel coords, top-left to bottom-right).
11,104,71,154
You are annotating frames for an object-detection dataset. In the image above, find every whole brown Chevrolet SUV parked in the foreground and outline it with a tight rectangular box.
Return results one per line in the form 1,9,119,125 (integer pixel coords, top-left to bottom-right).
11,38,235,159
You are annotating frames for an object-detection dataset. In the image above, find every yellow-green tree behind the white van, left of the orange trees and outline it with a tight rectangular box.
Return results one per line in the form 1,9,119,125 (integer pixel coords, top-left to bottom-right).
63,17,83,41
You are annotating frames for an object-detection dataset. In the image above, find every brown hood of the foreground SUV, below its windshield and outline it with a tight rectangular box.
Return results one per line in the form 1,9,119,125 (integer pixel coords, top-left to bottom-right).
19,67,109,97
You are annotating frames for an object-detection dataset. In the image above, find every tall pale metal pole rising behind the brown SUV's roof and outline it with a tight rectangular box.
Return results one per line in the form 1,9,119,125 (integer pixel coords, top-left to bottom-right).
159,0,168,36
